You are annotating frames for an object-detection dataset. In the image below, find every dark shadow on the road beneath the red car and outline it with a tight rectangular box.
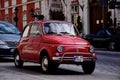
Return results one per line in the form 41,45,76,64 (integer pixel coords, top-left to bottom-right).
5,65,85,76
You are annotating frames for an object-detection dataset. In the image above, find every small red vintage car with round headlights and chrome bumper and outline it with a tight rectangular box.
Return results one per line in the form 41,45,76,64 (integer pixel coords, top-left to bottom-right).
14,20,96,74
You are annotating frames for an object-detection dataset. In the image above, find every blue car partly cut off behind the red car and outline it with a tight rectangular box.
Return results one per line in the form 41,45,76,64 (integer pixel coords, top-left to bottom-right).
0,21,20,57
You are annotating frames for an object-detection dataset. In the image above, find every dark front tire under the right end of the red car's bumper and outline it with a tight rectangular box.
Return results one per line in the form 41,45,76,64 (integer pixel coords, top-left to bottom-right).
82,62,95,74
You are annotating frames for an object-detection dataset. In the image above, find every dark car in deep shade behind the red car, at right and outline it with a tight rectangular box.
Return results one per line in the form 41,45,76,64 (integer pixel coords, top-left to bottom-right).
84,28,120,50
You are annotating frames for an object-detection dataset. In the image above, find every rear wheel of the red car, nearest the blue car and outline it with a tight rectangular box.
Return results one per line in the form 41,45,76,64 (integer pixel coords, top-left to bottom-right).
14,52,23,68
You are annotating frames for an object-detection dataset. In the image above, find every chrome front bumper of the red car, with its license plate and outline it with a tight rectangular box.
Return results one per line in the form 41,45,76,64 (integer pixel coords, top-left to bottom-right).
52,52,96,62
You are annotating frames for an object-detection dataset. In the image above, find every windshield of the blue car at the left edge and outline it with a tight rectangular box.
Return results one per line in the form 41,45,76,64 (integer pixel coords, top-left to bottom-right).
0,23,20,34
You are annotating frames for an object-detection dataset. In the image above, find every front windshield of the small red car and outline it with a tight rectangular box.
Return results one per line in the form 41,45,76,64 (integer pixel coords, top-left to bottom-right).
44,22,76,36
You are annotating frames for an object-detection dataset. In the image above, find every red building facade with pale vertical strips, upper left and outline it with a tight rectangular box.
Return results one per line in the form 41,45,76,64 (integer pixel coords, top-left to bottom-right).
0,0,41,31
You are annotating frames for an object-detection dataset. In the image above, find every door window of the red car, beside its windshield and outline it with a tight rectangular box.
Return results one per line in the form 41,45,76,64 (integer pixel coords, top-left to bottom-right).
30,24,40,36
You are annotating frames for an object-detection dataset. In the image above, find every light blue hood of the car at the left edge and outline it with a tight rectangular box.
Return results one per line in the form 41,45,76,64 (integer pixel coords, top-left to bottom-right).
0,34,21,42
